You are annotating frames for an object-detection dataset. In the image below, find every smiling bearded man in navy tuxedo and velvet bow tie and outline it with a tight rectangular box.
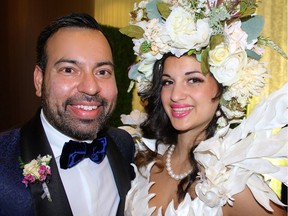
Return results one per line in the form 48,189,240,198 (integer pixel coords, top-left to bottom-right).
0,14,134,216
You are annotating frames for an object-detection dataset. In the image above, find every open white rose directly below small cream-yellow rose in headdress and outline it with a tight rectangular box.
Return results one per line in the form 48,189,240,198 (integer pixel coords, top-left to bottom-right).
210,51,247,86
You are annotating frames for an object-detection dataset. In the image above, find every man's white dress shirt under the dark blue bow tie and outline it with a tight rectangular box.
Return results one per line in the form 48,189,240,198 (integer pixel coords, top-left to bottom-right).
40,110,120,216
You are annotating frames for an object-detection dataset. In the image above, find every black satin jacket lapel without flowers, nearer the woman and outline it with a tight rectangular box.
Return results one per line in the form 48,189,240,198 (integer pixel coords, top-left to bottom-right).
107,135,131,216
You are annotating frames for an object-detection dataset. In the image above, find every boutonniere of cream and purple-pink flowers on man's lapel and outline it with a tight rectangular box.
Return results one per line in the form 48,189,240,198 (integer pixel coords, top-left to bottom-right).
20,155,52,202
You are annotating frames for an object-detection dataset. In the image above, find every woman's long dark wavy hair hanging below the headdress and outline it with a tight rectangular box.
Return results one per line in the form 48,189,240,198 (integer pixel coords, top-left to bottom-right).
135,53,225,201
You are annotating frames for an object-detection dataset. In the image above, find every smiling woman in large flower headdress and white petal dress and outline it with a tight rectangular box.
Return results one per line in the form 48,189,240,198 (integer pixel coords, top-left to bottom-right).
121,0,288,216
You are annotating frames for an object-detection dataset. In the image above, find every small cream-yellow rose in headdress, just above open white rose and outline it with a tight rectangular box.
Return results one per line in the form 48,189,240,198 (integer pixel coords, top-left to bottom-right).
209,43,230,66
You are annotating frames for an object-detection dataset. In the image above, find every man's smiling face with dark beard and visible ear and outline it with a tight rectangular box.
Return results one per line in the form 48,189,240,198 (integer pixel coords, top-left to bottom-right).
34,28,118,140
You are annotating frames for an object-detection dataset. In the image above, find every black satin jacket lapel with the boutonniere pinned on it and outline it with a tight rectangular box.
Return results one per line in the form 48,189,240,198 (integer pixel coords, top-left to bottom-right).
20,111,72,216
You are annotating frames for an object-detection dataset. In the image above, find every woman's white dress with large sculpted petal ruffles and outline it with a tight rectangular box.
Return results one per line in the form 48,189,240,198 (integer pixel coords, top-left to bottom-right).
125,83,288,216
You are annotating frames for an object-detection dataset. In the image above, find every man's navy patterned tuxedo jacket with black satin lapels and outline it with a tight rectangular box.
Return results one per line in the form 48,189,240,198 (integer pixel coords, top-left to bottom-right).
0,112,134,216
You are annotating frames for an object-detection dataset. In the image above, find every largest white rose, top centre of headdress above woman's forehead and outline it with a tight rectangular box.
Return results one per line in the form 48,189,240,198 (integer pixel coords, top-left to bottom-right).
165,7,212,57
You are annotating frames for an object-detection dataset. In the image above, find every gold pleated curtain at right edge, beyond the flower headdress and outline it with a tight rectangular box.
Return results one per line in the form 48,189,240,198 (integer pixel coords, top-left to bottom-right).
248,0,288,113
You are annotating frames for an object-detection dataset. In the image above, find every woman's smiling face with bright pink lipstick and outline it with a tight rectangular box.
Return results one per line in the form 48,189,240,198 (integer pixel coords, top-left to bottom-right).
161,56,219,132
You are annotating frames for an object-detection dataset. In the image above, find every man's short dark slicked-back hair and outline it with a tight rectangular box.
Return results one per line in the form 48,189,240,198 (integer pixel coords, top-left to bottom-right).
36,13,112,72
